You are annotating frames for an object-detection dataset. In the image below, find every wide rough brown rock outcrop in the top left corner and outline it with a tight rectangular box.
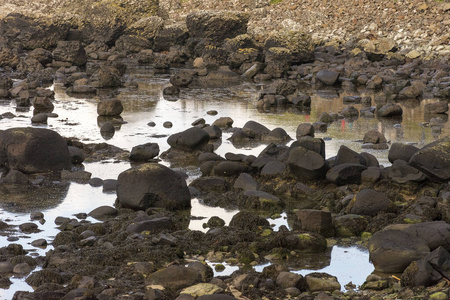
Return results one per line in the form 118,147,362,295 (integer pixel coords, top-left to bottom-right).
0,13,70,49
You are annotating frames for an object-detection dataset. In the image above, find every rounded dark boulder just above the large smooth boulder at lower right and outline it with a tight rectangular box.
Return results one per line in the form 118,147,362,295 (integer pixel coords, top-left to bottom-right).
350,189,391,216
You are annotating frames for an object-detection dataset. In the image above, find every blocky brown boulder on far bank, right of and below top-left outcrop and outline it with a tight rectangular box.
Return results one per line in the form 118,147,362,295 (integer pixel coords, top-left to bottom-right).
52,41,87,66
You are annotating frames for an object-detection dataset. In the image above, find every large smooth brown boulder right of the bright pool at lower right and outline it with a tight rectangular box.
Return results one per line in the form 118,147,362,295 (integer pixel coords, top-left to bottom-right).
369,229,430,273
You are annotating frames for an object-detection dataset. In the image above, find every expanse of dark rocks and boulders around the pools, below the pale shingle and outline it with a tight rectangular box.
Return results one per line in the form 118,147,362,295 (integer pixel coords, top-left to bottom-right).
0,1,450,300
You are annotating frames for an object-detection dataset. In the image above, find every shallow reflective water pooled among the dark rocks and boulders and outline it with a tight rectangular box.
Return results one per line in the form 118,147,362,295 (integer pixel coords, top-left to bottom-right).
0,63,450,299
